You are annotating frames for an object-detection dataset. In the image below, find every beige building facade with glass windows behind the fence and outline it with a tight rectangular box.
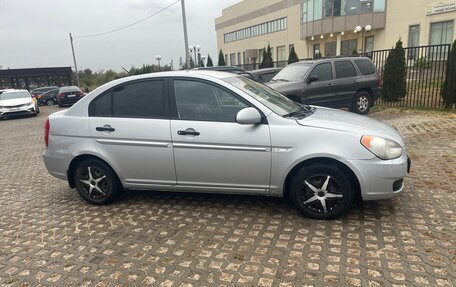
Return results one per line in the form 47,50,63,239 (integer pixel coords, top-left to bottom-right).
215,0,456,65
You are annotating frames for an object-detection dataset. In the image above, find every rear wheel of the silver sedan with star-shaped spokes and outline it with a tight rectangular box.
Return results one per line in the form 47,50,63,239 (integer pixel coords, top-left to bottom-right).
73,159,122,205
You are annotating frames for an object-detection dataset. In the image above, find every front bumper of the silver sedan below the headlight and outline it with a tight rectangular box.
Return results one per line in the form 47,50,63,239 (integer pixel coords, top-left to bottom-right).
350,153,410,200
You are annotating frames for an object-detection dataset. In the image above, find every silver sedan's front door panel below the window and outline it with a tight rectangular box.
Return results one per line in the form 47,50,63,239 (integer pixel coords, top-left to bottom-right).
171,120,271,193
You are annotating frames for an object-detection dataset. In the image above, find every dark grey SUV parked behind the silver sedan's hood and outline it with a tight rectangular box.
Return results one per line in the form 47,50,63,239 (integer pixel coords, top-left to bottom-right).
268,57,381,114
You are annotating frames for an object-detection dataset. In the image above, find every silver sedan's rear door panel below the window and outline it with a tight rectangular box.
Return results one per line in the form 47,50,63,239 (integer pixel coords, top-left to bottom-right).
89,117,176,184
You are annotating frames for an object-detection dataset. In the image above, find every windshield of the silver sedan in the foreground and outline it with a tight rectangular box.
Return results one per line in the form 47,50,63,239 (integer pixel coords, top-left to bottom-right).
223,76,303,117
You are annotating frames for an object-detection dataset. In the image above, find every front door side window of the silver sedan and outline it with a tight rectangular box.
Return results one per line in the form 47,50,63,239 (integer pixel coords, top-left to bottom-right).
174,80,247,122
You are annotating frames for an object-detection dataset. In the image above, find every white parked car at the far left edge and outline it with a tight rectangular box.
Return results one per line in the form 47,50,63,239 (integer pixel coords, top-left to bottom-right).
0,89,39,119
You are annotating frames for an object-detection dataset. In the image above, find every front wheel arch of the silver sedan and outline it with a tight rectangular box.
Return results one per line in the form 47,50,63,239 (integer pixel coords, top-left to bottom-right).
283,157,362,200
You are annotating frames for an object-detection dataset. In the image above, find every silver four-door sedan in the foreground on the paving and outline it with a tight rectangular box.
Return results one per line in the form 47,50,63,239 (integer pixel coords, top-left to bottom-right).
43,71,408,219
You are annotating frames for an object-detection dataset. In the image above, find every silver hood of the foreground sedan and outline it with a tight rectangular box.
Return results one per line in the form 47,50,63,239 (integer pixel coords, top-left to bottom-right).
296,107,404,146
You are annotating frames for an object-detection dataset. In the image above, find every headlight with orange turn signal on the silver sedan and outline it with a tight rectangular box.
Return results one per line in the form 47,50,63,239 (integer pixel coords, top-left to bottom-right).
361,135,402,160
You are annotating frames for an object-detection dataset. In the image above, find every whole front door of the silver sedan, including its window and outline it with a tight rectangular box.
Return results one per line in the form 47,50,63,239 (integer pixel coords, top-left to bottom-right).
170,78,271,194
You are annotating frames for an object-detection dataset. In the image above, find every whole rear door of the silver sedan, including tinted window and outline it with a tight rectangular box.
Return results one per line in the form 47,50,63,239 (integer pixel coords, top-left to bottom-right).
89,79,176,187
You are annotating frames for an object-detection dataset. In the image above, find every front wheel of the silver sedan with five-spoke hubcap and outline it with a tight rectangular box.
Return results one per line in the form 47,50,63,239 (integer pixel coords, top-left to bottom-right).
291,164,354,219
